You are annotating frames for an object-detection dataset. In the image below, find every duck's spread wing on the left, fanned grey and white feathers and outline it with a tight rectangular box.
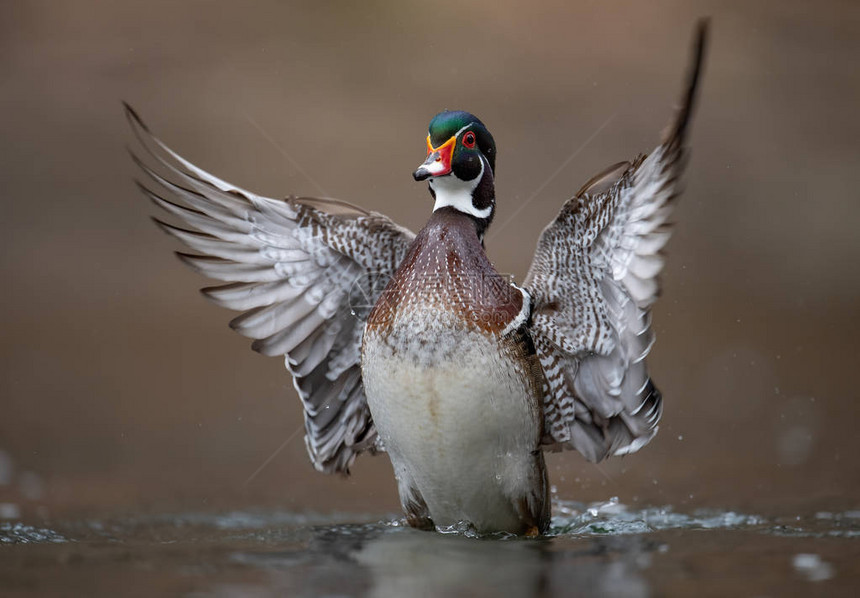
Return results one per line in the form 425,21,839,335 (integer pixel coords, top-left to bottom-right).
126,105,415,473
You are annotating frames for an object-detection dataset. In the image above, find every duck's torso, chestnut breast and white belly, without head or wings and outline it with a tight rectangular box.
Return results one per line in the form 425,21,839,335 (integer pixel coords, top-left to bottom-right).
361,207,549,533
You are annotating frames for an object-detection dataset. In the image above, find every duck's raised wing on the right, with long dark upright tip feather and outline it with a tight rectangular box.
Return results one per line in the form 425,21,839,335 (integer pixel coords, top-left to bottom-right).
525,22,707,461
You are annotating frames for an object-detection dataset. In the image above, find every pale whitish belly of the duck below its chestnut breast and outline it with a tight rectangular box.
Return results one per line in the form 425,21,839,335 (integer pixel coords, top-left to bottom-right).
362,330,540,530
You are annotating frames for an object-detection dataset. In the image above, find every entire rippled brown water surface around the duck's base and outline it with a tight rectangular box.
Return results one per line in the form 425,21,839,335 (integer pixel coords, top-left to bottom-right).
0,500,860,597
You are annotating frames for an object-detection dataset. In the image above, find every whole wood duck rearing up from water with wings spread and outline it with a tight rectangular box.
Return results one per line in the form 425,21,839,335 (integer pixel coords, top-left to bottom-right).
126,22,707,535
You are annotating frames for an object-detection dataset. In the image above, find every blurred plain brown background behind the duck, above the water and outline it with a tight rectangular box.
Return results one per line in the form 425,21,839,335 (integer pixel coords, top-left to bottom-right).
0,0,860,512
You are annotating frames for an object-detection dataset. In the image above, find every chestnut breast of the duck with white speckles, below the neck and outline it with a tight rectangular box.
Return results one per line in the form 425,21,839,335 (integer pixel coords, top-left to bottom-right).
367,207,523,344
